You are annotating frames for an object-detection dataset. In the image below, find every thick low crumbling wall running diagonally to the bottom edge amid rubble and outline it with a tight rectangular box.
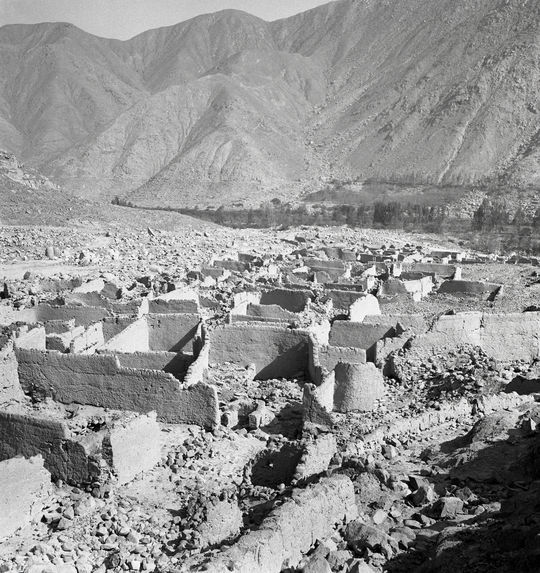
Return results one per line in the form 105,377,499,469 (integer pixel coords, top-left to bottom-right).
195,475,358,573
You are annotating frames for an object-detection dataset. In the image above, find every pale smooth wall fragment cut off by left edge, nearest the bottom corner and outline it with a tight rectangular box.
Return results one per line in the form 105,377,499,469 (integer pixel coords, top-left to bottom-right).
0,456,51,541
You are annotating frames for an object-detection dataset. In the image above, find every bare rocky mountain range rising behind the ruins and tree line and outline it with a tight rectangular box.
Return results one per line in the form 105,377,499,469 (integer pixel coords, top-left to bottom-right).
0,0,540,206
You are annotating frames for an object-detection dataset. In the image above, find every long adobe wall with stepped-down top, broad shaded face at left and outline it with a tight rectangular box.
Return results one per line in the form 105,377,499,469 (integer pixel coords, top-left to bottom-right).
17,350,218,427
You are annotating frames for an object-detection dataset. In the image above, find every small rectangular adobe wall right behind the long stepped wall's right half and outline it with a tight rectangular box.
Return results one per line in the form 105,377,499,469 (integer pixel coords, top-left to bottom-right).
144,313,201,352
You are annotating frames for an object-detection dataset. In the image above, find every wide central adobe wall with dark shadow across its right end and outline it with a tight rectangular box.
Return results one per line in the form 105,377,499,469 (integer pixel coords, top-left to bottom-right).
209,324,309,379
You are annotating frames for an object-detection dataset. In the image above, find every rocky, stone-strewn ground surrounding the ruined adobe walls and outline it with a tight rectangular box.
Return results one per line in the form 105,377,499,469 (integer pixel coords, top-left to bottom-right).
0,220,540,573
